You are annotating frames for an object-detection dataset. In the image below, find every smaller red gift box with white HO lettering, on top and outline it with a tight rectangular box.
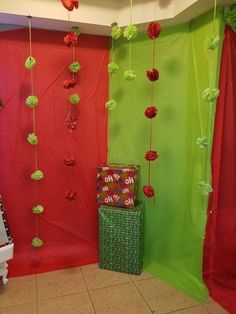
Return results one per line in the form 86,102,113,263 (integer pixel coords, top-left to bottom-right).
97,165,139,208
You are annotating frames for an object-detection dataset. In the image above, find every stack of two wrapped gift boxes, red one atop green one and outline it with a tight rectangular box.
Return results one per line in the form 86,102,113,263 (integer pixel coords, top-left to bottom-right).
97,165,143,275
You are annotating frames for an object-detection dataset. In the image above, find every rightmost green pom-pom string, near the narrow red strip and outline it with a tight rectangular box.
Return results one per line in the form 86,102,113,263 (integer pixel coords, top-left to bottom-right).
196,0,220,196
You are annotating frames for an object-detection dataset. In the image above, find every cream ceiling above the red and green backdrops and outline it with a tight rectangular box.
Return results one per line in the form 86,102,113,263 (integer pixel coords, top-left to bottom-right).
0,0,234,35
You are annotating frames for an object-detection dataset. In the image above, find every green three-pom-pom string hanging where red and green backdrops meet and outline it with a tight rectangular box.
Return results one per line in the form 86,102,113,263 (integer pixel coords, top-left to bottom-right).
105,22,122,110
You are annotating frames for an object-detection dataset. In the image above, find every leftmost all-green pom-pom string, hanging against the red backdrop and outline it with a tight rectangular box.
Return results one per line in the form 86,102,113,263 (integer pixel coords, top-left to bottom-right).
24,16,44,247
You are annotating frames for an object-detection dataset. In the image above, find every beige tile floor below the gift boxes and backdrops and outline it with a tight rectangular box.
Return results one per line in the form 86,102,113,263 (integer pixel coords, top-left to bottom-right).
0,264,227,314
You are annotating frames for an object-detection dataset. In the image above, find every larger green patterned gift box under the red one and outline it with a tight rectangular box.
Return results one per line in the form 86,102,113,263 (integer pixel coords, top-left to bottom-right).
99,202,144,275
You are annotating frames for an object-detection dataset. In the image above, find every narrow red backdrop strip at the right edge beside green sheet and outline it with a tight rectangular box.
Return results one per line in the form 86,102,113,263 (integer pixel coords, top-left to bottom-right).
203,27,236,314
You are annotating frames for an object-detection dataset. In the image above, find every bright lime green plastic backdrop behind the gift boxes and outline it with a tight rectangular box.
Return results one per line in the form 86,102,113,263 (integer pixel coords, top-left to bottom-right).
109,9,223,301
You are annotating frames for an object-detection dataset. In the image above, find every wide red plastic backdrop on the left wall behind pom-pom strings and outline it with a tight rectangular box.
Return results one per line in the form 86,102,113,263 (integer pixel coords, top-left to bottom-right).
0,29,109,276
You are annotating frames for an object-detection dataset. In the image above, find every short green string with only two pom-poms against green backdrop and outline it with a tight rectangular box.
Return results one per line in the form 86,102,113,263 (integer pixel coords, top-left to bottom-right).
123,0,138,81
